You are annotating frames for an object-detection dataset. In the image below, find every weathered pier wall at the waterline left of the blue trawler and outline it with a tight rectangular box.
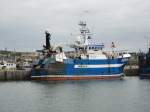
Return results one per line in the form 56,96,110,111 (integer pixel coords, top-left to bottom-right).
0,70,30,81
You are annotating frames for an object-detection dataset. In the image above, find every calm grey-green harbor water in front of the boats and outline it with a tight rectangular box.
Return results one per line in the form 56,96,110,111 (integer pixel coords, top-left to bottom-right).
0,77,150,112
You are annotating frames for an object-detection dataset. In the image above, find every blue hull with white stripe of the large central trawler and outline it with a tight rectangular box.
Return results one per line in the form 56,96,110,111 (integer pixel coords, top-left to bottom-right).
31,58,127,78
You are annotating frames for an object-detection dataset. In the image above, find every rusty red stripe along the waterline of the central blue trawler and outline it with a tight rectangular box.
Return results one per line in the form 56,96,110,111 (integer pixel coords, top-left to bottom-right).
31,76,121,81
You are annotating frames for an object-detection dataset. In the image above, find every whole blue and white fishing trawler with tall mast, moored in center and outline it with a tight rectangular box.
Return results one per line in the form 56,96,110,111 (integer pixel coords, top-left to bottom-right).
31,21,130,81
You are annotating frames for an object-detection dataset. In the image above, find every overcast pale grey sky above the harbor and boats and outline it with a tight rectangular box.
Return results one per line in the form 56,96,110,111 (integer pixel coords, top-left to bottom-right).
0,0,150,51
